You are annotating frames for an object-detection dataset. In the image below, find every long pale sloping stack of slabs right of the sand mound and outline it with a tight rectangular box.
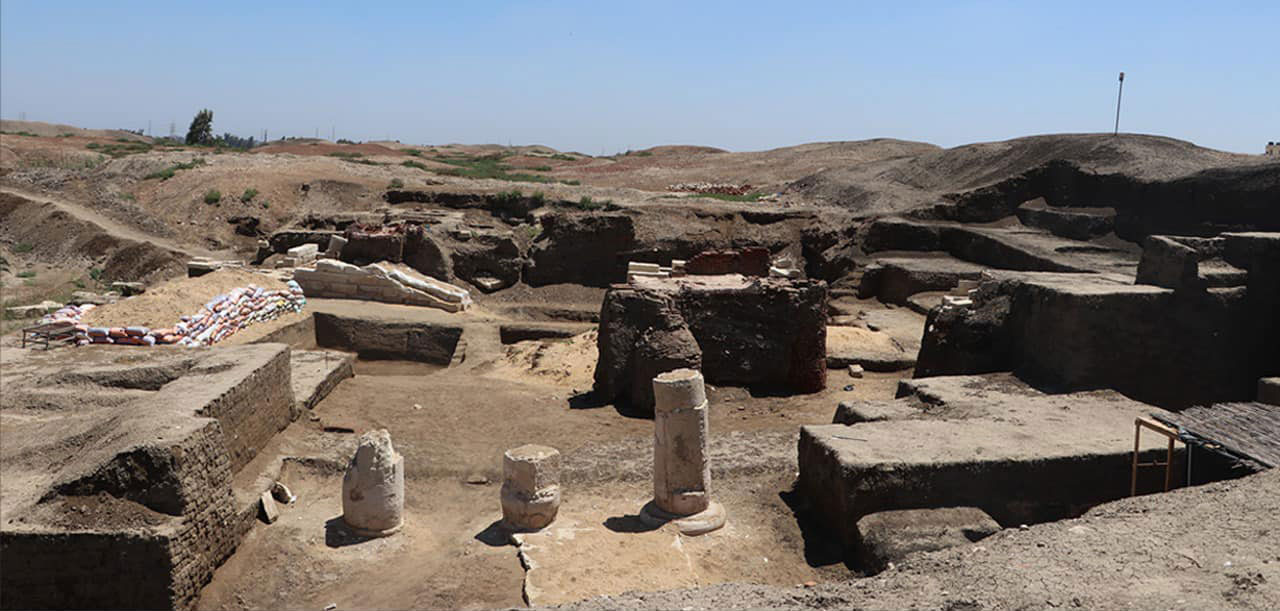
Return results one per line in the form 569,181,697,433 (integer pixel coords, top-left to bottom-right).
293,259,471,313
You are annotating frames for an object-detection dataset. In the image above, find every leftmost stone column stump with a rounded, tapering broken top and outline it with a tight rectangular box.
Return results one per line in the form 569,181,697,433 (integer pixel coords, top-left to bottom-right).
342,429,404,537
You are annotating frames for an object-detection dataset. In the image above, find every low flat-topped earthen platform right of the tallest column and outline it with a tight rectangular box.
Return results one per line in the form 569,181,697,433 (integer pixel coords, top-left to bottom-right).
799,377,1181,544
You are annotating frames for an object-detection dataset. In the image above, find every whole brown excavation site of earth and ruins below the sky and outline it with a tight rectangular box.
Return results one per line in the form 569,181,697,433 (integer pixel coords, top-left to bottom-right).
0,122,1280,610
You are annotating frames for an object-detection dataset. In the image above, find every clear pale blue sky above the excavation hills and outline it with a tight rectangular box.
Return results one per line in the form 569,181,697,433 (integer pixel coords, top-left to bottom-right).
0,0,1280,154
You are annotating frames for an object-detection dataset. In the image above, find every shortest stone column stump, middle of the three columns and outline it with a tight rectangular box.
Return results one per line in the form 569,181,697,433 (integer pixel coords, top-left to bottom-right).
502,444,559,530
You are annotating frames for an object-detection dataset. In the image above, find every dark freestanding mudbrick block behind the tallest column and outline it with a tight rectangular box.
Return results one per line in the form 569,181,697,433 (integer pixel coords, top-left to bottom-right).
594,277,827,412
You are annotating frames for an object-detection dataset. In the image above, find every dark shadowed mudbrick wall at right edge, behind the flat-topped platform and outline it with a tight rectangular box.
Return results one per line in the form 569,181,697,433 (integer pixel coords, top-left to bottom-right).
915,233,1280,409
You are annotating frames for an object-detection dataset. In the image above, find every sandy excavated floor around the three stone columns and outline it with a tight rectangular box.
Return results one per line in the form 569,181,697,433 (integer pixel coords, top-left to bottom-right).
192,295,901,608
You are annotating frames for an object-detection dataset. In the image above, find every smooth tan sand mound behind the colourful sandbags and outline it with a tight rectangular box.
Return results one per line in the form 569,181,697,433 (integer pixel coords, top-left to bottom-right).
83,269,288,328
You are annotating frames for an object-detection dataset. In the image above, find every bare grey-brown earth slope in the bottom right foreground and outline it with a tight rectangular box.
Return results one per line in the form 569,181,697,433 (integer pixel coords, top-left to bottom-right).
566,470,1280,610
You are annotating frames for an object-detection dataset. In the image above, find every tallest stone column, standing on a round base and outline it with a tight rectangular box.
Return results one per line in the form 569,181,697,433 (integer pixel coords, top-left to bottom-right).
641,369,724,534
